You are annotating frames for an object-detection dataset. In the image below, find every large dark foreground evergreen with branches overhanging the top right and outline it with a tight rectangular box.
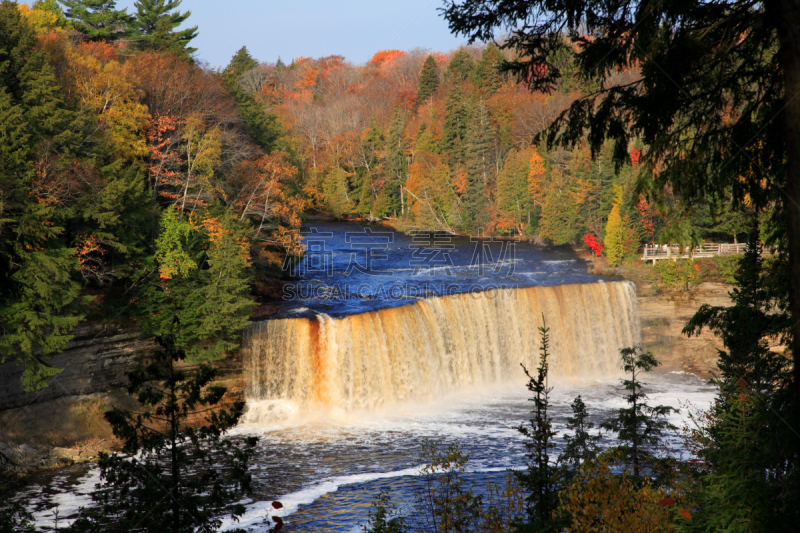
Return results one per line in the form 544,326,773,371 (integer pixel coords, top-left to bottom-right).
444,0,800,426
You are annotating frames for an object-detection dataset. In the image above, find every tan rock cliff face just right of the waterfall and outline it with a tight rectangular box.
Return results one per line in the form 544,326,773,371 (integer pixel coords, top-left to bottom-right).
637,283,732,376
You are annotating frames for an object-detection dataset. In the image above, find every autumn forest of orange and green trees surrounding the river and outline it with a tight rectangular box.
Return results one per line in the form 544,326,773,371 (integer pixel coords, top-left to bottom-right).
0,0,800,531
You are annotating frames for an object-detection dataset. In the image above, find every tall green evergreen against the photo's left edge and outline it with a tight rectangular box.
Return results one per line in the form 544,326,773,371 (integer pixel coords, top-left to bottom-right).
0,2,82,390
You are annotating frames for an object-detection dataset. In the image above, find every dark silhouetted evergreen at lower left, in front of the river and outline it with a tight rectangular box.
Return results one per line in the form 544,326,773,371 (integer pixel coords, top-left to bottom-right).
71,335,258,533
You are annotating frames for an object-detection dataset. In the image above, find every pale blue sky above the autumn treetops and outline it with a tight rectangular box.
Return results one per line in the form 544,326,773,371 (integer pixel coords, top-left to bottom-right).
117,0,466,67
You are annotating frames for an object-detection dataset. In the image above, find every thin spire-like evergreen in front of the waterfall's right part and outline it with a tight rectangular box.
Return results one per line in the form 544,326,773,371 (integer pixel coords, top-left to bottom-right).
514,317,560,532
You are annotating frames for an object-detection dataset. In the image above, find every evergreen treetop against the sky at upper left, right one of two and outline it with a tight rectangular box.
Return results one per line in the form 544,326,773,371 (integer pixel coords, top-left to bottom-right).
133,0,197,56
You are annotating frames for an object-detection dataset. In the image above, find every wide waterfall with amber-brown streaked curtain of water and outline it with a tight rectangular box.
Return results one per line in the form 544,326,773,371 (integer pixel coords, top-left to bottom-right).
244,282,640,423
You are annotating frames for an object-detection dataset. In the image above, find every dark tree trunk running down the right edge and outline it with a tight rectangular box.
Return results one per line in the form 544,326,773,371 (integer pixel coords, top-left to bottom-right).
765,0,800,429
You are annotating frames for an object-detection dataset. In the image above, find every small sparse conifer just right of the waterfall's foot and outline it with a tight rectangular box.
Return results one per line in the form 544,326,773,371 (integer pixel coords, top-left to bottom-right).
601,348,676,480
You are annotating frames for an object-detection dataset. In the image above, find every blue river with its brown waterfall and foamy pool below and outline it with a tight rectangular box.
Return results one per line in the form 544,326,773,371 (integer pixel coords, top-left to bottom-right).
23,223,714,532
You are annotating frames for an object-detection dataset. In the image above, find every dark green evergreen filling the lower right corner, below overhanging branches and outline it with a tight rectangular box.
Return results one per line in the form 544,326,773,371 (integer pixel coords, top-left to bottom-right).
680,221,800,533
